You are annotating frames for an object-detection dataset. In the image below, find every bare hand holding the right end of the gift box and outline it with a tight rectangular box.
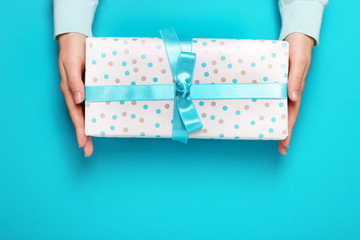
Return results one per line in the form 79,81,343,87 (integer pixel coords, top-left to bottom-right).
278,33,314,155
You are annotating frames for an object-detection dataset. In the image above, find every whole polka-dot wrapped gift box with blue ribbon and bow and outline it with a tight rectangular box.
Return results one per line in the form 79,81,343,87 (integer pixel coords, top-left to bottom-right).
85,28,289,142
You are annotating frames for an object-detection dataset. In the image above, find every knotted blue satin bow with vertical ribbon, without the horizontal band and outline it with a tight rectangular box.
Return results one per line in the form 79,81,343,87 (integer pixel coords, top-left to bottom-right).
160,28,203,143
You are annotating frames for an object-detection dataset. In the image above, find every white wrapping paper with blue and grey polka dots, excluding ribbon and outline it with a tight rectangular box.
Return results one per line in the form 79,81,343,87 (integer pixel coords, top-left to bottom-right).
85,38,289,140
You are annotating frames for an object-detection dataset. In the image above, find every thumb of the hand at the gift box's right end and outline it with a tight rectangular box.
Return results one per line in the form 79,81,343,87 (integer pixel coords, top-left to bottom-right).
288,56,307,102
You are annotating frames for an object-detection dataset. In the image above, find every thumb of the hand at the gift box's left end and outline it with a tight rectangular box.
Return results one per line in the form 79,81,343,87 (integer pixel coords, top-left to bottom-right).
63,58,84,104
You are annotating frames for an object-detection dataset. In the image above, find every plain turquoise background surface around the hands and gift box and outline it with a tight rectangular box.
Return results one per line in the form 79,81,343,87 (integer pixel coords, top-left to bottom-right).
0,0,360,240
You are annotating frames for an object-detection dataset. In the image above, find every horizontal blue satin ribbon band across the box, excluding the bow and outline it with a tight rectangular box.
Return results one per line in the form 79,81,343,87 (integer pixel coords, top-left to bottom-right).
85,83,287,102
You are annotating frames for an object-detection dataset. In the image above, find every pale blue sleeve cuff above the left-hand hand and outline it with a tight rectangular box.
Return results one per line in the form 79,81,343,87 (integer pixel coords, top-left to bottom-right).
53,0,98,38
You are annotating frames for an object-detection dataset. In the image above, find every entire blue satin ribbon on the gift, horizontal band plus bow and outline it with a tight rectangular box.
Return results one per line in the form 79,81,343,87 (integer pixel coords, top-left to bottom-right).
85,28,287,143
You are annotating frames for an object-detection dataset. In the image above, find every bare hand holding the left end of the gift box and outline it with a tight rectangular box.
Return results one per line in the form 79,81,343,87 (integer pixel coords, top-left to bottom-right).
59,33,93,157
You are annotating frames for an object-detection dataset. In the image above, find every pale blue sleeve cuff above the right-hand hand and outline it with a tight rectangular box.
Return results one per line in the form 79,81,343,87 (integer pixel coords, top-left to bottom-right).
279,0,328,45
